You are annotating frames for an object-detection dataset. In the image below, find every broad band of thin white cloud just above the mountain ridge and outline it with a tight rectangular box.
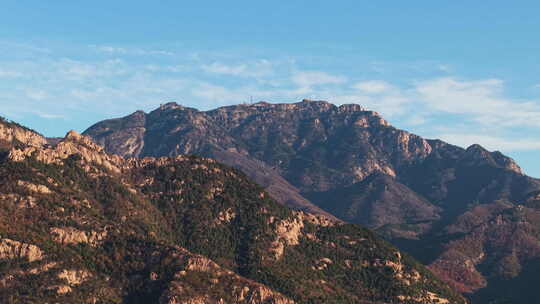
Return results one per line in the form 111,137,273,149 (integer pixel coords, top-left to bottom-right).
0,39,540,162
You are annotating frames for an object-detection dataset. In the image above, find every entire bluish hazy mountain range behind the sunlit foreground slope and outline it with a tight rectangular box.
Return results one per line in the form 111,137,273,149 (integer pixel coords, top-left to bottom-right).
84,100,540,303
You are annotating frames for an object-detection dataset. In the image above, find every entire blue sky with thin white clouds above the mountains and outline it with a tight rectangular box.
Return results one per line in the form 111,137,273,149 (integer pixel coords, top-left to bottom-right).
0,0,540,177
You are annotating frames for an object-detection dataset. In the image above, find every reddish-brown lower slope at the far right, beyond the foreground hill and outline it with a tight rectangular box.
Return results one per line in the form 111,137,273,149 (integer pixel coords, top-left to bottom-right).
429,192,540,303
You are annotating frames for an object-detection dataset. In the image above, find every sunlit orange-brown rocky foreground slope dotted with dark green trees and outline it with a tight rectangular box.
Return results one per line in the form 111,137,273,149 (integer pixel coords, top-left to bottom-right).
0,124,465,304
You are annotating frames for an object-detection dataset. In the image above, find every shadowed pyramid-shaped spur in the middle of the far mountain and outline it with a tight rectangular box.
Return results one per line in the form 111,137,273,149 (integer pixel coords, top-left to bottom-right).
308,172,441,239
